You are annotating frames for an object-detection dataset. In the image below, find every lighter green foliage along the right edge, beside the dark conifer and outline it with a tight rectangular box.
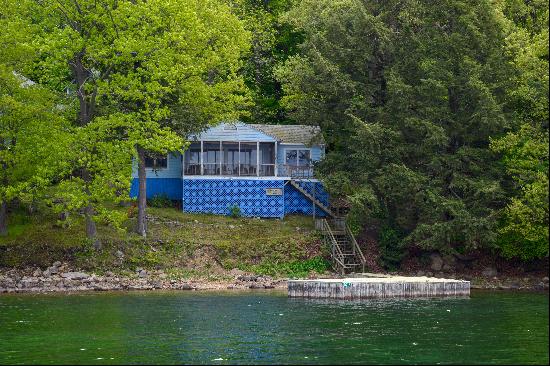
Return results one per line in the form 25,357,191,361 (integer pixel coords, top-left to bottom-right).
491,0,549,260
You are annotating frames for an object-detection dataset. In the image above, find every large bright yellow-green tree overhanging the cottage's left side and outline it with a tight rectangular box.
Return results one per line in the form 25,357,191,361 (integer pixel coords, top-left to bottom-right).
7,0,247,248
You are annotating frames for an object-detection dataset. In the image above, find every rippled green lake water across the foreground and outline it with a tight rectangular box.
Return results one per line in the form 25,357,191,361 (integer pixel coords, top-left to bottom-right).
0,291,549,364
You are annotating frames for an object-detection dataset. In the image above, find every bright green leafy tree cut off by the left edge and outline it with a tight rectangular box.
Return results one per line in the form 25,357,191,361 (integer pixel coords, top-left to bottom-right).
0,2,69,235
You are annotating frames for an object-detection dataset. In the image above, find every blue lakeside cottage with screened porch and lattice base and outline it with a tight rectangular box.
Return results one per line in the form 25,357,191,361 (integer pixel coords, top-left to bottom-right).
130,122,332,218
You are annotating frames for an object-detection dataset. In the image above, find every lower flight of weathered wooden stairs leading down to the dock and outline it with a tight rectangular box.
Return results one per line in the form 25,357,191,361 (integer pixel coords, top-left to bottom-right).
316,218,366,274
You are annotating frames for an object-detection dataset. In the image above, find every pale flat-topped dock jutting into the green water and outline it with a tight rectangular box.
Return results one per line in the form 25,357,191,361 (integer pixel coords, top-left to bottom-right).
288,274,470,300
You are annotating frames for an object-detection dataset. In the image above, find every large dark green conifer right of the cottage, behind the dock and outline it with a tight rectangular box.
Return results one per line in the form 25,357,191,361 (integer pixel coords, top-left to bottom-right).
277,0,510,260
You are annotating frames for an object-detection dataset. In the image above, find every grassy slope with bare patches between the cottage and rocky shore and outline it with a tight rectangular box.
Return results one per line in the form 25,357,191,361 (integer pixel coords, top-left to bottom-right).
0,207,328,279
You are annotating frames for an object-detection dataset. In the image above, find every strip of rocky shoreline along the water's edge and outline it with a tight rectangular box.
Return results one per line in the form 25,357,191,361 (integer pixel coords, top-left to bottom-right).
0,262,549,294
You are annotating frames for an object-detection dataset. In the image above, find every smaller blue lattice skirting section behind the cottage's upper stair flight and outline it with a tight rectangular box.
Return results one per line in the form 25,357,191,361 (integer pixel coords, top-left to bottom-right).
285,181,329,217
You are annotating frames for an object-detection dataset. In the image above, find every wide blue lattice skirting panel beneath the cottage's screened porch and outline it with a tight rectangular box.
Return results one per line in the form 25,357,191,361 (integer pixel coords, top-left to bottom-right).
183,179,285,218
